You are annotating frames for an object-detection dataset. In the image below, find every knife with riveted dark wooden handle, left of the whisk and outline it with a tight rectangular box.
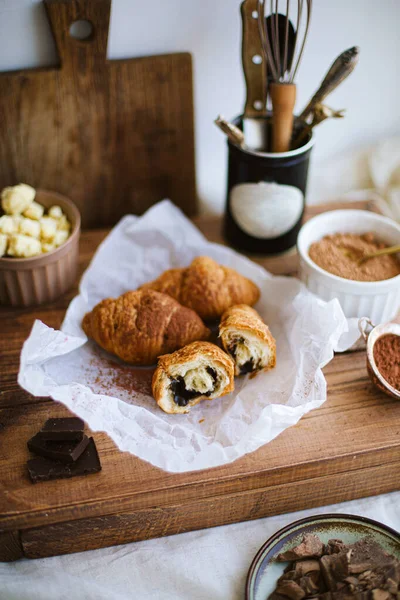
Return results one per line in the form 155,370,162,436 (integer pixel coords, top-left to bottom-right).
241,0,267,150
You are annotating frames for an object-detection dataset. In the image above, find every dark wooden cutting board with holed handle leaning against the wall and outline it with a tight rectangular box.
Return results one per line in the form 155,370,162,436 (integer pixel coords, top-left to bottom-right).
0,0,196,227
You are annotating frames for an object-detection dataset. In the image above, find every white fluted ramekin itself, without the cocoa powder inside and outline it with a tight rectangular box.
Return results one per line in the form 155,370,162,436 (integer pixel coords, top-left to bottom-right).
297,209,400,325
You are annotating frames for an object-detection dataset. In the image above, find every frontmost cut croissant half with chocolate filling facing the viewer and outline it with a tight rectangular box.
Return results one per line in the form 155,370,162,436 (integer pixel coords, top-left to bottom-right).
152,342,234,414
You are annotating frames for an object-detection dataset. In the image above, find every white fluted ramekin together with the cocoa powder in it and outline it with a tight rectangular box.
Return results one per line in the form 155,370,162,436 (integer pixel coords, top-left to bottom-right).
297,209,400,324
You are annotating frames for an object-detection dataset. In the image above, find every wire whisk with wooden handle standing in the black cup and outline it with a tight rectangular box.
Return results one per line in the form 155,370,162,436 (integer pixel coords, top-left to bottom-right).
258,0,312,152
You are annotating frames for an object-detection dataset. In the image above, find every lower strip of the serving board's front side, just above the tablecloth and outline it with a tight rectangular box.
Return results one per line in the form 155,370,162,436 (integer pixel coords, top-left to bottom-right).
14,461,400,560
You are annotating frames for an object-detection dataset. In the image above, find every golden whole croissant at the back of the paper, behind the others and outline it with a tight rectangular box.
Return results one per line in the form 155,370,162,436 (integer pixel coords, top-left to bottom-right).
140,256,260,321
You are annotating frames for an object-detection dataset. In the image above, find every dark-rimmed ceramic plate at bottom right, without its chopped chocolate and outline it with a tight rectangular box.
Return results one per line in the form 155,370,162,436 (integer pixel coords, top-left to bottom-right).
246,514,400,600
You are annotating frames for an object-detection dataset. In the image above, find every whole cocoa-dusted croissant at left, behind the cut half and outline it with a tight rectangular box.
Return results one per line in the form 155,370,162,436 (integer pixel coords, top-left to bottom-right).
82,290,210,365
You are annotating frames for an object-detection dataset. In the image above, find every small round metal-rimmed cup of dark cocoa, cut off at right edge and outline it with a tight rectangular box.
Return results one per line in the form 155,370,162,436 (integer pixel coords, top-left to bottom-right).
358,314,400,400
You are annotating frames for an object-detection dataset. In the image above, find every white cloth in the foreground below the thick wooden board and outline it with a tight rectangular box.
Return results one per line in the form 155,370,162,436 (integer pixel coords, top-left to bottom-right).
0,492,400,600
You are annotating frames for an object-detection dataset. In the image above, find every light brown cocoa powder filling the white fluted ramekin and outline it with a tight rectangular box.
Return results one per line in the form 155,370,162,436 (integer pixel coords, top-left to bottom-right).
308,232,400,281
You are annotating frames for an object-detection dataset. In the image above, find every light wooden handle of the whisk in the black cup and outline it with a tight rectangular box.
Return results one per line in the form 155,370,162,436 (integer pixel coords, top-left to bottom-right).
269,83,296,152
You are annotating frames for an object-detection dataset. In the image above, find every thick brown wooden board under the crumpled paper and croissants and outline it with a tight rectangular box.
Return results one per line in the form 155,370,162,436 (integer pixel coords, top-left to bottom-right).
0,203,400,561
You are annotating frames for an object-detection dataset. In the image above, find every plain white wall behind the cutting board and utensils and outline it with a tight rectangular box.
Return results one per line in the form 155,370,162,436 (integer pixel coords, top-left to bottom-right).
0,0,400,211
